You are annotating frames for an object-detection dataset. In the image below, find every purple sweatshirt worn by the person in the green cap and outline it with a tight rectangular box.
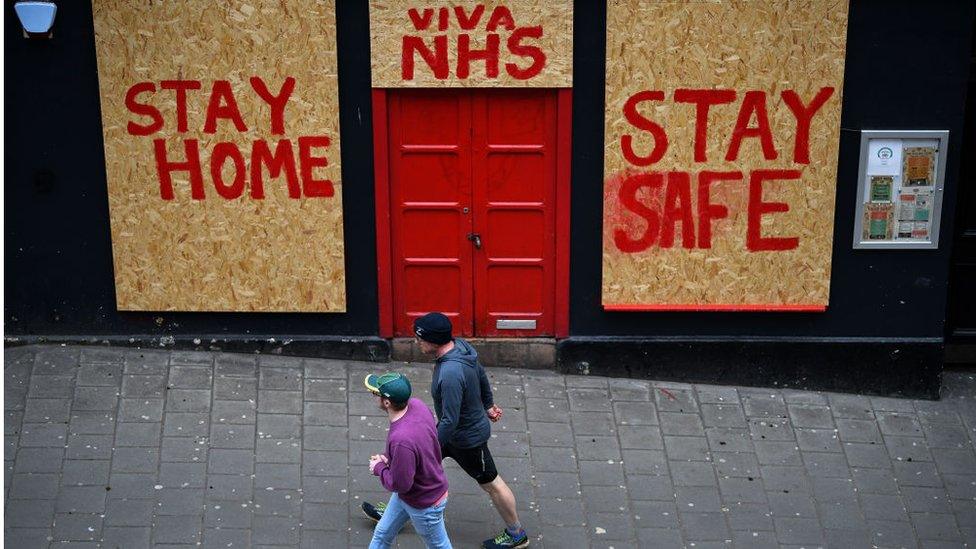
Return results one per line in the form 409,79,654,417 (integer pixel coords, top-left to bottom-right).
373,398,447,509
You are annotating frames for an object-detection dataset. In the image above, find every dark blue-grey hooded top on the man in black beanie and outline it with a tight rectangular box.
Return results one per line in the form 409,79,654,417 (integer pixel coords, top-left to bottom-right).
430,337,495,448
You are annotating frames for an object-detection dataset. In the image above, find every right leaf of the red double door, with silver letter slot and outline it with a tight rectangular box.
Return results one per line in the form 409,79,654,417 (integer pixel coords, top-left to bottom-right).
472,90,556,337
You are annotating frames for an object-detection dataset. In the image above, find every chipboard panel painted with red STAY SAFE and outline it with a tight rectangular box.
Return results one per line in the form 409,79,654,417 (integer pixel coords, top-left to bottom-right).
603,0,847,310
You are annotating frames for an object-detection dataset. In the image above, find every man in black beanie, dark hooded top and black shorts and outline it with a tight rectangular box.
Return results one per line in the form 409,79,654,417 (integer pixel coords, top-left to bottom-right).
363,313,529,549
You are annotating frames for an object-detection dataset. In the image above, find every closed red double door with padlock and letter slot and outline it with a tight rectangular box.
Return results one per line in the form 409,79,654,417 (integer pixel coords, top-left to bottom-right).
387,89,557,337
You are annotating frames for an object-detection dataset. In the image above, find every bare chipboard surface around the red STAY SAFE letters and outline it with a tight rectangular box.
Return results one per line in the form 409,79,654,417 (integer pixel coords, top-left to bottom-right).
602,0,847,310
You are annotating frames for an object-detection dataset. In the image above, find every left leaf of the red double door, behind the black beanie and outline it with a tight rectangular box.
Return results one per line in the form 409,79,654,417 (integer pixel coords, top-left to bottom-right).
387,90,473,336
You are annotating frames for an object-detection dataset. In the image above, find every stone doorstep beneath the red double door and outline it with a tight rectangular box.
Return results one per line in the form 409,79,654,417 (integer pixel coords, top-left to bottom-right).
390,337,556,370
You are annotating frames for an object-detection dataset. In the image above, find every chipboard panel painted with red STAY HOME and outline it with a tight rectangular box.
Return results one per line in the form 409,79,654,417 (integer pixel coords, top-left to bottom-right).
94,0,346,312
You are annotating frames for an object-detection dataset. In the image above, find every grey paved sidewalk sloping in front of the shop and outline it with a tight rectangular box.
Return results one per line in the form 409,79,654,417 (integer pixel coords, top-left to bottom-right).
4,346,976,549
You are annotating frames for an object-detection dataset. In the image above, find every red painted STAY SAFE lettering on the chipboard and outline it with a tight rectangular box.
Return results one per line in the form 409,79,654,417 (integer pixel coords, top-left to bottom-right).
613,87,834,253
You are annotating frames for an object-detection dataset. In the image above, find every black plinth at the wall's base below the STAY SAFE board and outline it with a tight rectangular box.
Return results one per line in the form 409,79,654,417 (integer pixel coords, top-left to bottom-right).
556,337,945,399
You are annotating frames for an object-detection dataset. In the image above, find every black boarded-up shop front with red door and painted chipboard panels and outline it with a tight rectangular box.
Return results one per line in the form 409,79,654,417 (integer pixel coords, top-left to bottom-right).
5,0,974,396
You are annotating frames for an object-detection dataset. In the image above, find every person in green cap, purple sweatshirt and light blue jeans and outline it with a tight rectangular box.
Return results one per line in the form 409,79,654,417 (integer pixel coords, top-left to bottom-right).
365,372,451,549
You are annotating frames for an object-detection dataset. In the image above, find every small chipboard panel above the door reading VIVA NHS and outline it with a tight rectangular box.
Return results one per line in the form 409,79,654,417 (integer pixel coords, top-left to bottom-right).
369,0,573,88
